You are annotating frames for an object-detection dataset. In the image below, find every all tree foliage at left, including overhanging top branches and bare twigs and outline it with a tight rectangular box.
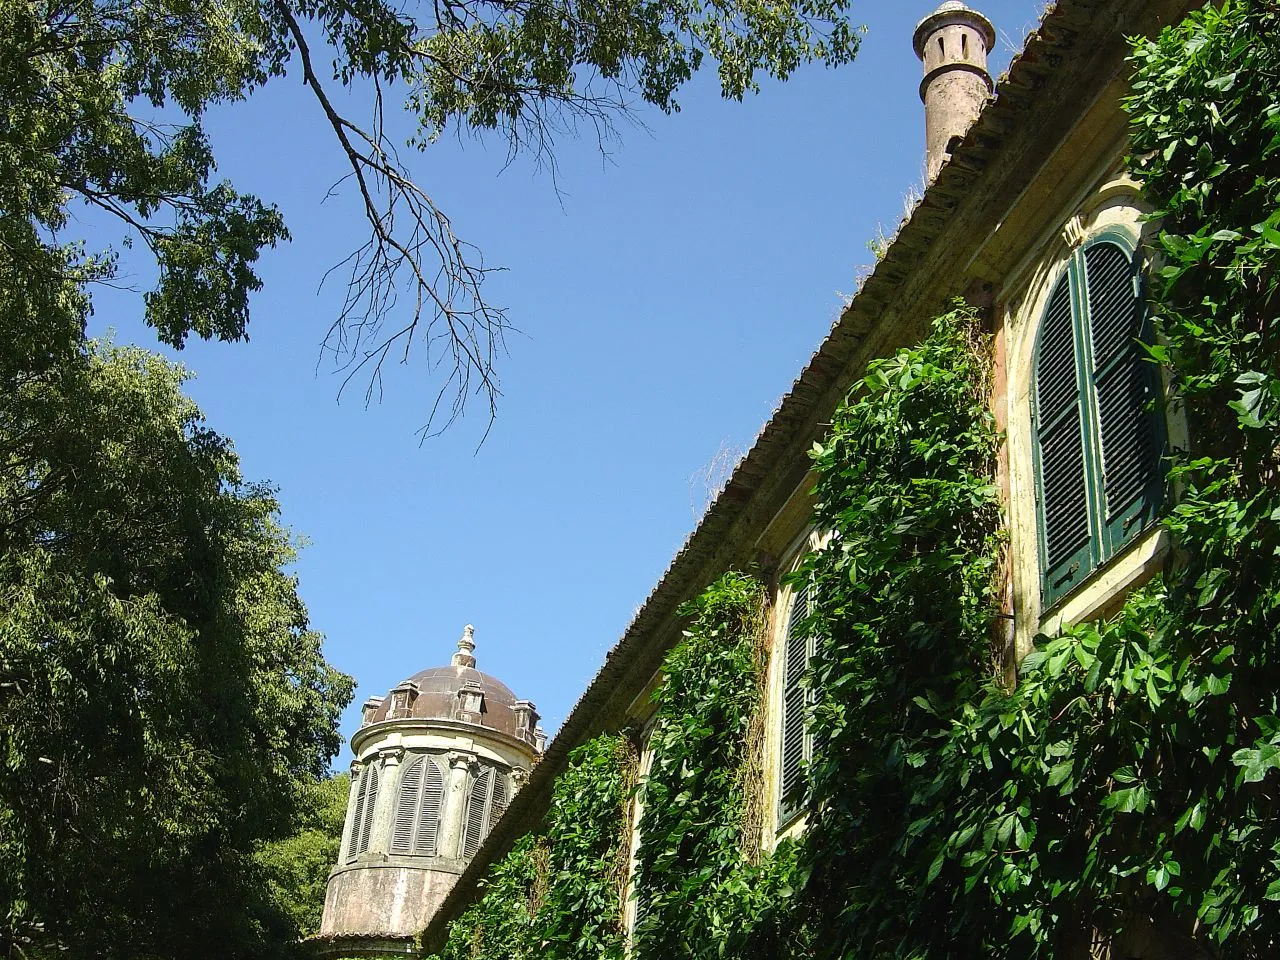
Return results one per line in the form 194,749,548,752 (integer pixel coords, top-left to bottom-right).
0,0,856,960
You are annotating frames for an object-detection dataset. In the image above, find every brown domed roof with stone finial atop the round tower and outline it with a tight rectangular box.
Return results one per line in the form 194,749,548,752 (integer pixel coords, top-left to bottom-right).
364,623,541,746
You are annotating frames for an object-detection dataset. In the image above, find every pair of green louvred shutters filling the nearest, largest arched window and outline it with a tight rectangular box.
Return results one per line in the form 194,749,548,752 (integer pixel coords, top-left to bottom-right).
1032,232,1164,608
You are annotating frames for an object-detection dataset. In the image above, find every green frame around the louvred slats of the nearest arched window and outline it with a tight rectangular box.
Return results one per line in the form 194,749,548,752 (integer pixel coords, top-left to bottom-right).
1030,224,1169,616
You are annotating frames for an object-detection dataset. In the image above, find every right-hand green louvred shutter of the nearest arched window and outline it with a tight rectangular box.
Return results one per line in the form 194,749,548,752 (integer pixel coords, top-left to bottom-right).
1084,241,1164,556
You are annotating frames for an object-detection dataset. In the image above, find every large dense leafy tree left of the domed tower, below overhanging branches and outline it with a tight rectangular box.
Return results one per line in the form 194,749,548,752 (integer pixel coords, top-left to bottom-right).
0,343,351,957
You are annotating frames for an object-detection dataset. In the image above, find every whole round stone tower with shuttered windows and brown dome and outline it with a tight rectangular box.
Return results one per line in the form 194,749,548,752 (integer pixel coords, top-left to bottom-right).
314,625,547,956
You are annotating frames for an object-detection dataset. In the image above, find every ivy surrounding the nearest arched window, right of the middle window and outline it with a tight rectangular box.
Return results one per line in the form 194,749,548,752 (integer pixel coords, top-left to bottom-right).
801,0,1280,957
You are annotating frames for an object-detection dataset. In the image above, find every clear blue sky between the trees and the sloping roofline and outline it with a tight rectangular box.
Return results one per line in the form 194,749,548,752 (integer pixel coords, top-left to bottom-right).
93,0,1043,767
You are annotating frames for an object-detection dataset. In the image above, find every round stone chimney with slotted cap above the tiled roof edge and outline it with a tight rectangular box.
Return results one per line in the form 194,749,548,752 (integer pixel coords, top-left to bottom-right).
913,0,996,180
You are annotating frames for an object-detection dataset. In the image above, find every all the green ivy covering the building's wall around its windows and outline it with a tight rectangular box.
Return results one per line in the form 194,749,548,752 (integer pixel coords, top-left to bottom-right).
422,0,1280,960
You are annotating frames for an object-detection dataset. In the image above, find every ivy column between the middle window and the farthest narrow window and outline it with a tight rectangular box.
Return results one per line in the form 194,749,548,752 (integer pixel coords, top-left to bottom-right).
634,572,782,960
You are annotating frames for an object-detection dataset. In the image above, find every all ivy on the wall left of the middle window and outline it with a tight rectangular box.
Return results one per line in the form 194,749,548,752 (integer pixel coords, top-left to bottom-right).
439,573,794,960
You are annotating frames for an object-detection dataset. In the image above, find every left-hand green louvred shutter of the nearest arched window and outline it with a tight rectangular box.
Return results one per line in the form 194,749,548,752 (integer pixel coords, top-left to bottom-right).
1032,274,1094,607
